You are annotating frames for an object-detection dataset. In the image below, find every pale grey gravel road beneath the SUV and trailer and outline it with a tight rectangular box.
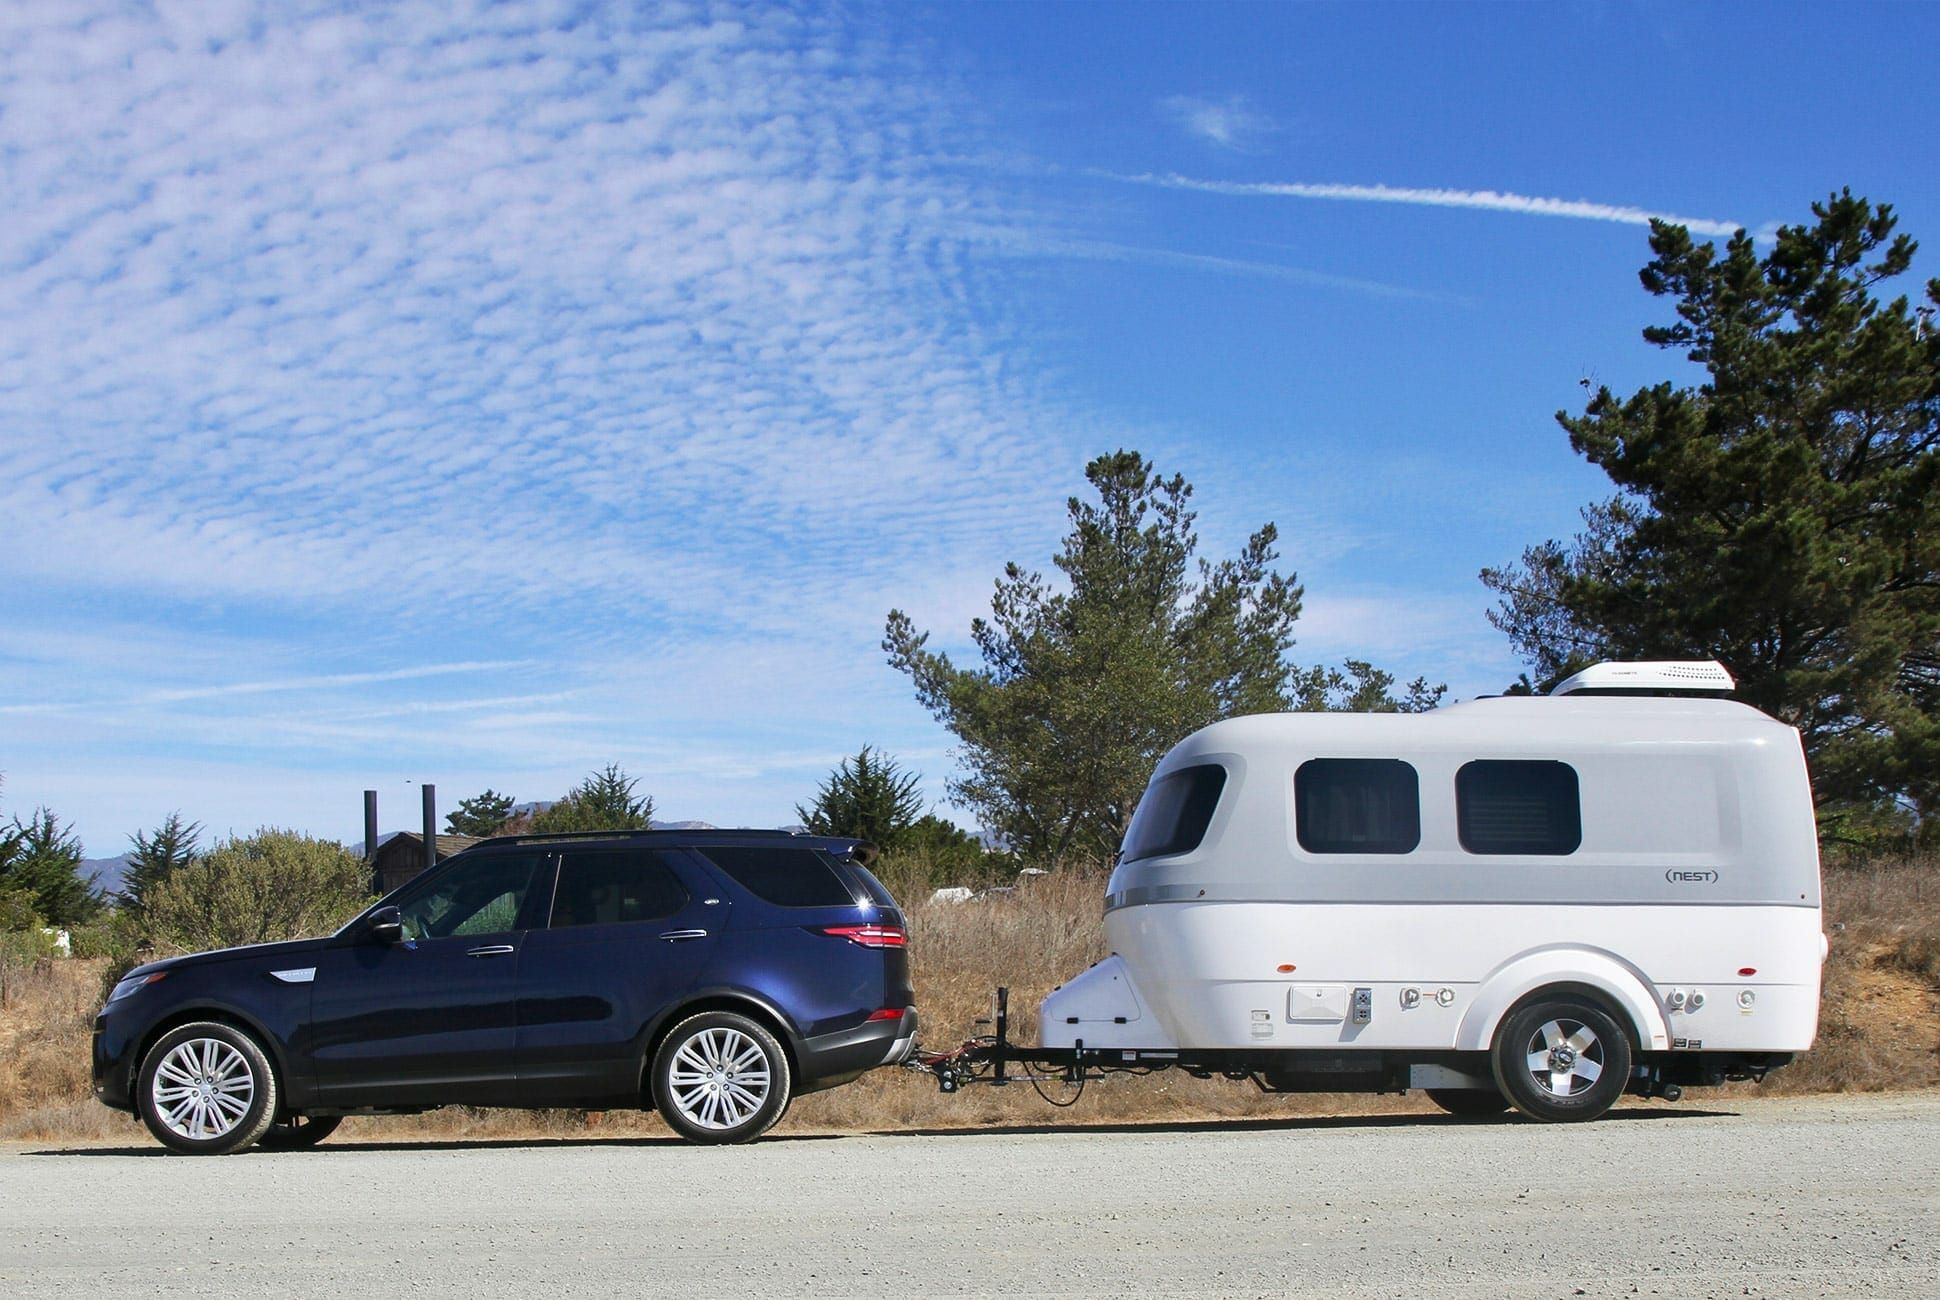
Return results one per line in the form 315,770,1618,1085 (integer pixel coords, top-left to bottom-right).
0,1094,1940,1296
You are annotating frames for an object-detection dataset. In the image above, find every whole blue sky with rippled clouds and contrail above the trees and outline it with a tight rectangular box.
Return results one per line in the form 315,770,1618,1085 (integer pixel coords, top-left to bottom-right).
0,0,1940,854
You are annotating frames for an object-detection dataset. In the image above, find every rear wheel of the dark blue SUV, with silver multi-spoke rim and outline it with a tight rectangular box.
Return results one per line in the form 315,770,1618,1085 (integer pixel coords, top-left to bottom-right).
654,1011,792,1143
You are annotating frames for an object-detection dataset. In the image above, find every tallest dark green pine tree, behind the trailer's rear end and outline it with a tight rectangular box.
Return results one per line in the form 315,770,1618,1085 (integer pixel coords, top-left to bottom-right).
1482,190,1940,817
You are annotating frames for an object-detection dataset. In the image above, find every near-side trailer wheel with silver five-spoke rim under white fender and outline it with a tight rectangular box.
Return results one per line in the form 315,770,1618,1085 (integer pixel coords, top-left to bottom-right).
1490,993,1630,1123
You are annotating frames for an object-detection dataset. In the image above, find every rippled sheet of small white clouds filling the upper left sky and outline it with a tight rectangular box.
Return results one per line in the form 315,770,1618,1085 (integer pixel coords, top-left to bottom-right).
0,0,1077,629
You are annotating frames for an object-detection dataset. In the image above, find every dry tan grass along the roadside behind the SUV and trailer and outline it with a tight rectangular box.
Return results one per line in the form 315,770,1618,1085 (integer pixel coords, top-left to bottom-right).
0,861,1940,1141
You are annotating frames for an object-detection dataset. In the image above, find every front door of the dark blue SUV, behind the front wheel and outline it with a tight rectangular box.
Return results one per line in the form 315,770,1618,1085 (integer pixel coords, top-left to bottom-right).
308,850,551,1106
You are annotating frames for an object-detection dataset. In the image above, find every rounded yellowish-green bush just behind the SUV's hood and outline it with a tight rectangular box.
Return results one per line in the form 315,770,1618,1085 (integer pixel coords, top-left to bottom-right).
144,829,371,953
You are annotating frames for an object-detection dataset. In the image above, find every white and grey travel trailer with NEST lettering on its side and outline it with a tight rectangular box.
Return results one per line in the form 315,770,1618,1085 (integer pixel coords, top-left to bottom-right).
1019,664,1826,1120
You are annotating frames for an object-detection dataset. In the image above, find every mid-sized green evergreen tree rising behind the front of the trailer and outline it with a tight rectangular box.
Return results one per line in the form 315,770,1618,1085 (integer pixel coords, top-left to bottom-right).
883,450,1300,865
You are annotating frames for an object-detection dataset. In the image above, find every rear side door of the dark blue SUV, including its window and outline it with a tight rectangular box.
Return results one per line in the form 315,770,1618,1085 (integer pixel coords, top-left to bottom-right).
518,844,728,1106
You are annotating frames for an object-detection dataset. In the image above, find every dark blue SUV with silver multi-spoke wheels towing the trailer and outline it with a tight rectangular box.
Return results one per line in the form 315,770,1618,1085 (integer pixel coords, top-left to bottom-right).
93,830,916,1154
